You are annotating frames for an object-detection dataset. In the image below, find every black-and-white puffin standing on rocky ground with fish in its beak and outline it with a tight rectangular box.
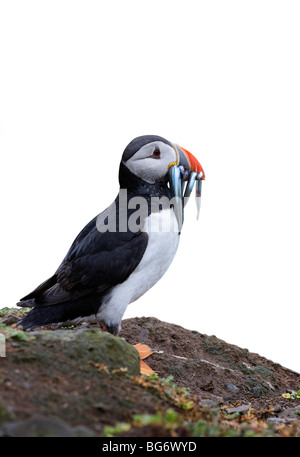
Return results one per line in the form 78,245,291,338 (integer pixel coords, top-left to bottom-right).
16,135,205,335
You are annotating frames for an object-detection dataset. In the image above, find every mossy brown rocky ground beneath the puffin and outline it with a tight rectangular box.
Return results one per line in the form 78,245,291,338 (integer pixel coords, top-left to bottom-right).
0,308,300,437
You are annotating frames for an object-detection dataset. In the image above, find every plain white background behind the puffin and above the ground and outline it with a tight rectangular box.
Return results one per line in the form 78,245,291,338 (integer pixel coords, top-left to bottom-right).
0,0,300,372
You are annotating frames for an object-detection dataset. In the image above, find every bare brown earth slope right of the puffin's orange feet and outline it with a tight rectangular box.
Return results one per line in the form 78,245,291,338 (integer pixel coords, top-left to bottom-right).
122,317,300,405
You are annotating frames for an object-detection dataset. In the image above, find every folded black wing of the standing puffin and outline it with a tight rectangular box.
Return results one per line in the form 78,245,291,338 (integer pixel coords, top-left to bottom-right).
18,210,148,306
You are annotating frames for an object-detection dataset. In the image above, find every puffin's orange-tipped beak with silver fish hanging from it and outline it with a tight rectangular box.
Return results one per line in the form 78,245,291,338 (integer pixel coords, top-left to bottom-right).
169,144,205,231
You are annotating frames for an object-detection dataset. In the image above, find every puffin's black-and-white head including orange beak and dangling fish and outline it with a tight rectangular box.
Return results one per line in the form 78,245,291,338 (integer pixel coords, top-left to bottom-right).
122,135,205,225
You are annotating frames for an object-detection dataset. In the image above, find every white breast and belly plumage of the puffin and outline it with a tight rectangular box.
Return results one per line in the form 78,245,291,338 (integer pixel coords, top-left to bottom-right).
97,209,179,324
